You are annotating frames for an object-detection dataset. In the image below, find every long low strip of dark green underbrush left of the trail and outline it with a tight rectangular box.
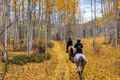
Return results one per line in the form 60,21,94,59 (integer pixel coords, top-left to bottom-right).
12,53,51,65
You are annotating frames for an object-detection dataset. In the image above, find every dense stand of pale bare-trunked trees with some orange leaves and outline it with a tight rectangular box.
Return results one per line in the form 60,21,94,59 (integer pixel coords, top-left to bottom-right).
0,0,119,51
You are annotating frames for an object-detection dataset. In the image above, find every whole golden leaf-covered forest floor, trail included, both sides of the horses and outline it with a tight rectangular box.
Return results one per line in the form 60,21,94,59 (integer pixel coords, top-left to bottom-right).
0,39,120,80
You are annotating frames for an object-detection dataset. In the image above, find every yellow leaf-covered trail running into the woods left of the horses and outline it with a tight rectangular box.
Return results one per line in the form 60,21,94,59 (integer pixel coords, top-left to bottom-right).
49,42,79,80
